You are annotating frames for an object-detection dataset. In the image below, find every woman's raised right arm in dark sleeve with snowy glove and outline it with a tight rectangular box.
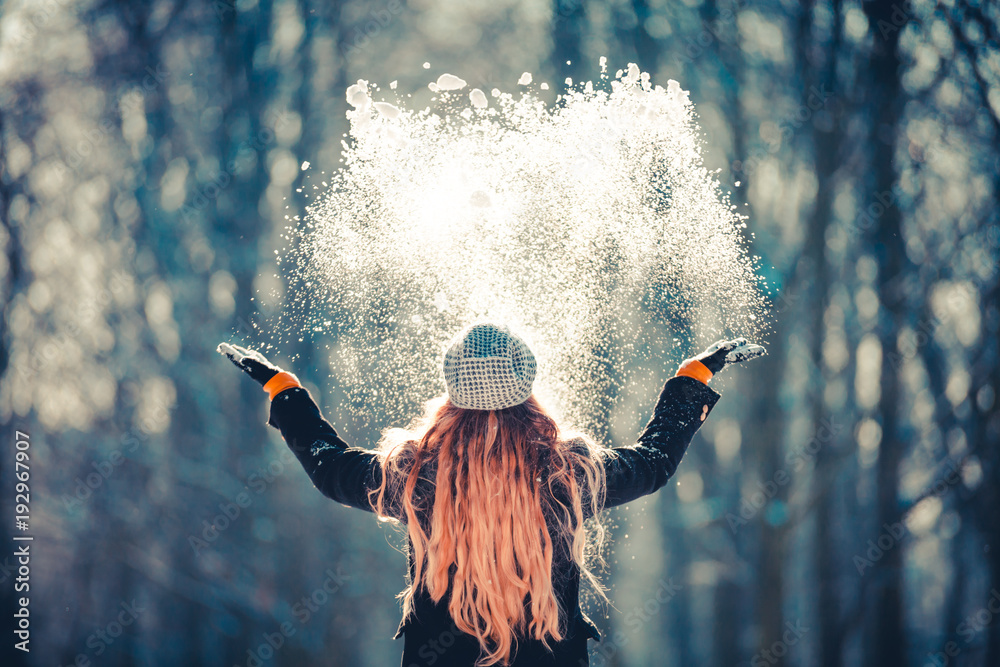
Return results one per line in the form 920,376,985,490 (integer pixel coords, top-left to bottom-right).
592,338,765,508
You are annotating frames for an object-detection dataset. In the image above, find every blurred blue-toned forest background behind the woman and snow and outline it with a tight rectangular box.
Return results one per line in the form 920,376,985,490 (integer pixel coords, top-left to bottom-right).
0,0,1000,667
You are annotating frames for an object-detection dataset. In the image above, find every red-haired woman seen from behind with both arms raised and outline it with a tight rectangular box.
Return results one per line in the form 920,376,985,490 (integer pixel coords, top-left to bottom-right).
219,323,765,667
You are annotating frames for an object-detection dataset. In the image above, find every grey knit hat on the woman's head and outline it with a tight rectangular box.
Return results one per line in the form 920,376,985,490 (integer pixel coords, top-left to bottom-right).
444,322,536,410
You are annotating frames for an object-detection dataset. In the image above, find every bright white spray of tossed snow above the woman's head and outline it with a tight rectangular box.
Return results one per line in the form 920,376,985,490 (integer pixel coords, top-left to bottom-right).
264,58,768,430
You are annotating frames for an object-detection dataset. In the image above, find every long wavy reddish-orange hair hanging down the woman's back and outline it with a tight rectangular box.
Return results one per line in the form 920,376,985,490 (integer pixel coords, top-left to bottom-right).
369,396,607,667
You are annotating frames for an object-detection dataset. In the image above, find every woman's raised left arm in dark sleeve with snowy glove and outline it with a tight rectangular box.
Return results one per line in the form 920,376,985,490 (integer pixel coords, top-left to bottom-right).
218,343,382,511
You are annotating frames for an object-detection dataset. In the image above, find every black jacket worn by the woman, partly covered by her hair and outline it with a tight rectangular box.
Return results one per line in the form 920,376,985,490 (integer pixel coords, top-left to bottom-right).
268,376,719,667
